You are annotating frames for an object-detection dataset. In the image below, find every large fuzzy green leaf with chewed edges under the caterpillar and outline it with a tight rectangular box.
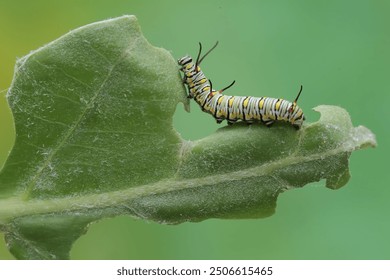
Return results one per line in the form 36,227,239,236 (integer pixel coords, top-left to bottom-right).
0,16,376,259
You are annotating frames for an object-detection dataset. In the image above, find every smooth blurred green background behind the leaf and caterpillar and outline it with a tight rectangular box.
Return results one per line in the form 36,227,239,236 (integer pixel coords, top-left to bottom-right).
0,0,390,259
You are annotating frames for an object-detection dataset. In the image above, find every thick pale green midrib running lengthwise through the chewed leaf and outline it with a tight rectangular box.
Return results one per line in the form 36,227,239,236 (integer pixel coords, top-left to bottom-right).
0,139,362,225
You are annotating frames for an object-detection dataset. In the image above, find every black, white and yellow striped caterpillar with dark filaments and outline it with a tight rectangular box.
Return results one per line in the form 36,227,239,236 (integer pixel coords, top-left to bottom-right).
178,42,305,129
